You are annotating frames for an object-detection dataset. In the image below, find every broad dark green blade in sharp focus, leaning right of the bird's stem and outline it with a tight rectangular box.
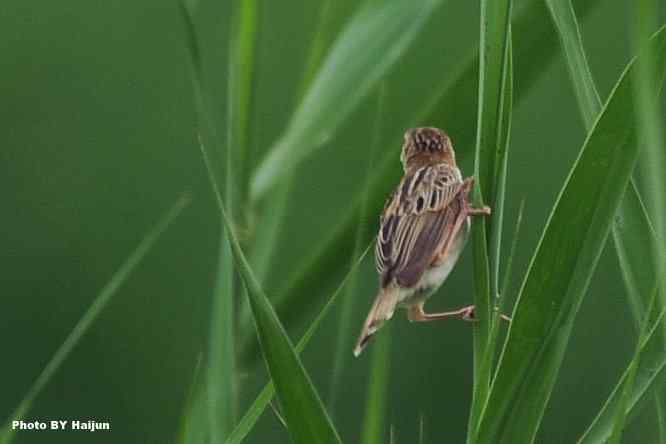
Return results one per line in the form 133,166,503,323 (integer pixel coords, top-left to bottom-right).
470,30,666,443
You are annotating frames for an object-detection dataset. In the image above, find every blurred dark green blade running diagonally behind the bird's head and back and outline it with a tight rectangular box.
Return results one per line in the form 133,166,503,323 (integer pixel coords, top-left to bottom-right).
240,0,599,361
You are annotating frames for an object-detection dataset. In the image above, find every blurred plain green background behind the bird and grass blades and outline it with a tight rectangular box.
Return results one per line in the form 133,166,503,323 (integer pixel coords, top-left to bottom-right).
0,0,654,443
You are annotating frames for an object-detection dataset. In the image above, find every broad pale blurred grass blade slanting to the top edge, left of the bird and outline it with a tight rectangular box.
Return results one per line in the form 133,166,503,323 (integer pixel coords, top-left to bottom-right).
251,0,441,200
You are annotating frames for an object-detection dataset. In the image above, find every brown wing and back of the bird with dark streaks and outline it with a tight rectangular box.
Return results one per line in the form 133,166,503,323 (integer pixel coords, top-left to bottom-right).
375,164,463,287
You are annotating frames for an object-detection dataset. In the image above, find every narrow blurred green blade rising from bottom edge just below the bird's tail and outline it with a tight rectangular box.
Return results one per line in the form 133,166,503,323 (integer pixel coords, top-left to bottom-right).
360,325,391,444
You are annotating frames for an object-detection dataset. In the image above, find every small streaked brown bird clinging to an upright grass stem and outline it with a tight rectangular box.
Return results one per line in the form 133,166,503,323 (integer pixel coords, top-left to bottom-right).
354,128,490,356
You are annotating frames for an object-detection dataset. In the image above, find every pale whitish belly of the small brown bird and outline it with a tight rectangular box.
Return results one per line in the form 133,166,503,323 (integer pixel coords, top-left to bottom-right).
399,217,470,307
